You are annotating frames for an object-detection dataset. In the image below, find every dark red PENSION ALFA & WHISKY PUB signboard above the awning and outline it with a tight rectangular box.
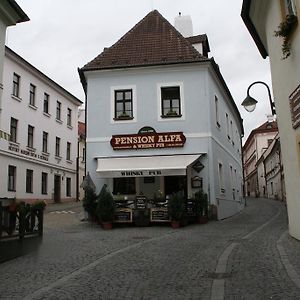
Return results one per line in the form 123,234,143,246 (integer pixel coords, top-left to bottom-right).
110,132,186,150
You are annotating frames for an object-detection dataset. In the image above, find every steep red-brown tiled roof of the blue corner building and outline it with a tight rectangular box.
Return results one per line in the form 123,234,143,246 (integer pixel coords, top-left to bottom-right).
82,10,207,71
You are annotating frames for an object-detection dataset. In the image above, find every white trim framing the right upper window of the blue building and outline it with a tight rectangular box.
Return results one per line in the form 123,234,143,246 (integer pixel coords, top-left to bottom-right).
156,81,185,122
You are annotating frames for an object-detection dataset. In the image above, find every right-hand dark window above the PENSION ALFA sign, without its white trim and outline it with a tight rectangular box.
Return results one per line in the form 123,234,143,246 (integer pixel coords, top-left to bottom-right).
161,86,181,118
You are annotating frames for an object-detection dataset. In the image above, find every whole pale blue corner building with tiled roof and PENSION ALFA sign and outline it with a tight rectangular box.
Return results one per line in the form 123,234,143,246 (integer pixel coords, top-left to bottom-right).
79,11,244,220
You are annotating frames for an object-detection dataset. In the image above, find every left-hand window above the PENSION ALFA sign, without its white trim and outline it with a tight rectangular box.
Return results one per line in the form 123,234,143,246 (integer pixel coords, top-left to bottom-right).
114,89,133,120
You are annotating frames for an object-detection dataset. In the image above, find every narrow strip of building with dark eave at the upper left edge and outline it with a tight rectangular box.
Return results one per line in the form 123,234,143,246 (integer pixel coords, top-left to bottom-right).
0,0,29,139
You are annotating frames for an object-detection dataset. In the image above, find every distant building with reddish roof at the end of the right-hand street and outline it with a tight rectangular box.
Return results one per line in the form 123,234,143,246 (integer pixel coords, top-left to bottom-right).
243,121,278,197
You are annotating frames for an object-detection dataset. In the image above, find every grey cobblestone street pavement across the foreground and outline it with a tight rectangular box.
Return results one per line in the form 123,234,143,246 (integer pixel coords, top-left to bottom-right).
0,199,300,300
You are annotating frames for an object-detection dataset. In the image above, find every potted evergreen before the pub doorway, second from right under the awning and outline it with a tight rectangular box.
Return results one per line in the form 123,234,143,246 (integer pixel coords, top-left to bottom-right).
168,192,185,228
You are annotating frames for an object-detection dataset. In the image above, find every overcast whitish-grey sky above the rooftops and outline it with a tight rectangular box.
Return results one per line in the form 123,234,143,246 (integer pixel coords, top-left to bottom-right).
6,0,271,141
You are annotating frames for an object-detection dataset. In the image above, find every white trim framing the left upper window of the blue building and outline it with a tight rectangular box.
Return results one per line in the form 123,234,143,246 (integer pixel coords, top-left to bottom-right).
110,85,137,124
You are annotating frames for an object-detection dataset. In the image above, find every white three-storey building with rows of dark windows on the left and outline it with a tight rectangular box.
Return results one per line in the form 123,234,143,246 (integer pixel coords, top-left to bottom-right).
0,47,81,202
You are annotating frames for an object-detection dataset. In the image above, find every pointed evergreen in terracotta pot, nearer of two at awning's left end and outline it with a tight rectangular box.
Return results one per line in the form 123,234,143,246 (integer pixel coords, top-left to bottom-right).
96,184,115,229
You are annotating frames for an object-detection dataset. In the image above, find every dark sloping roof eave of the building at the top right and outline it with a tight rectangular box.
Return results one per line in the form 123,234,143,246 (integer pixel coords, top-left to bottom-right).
241,0,268,58
